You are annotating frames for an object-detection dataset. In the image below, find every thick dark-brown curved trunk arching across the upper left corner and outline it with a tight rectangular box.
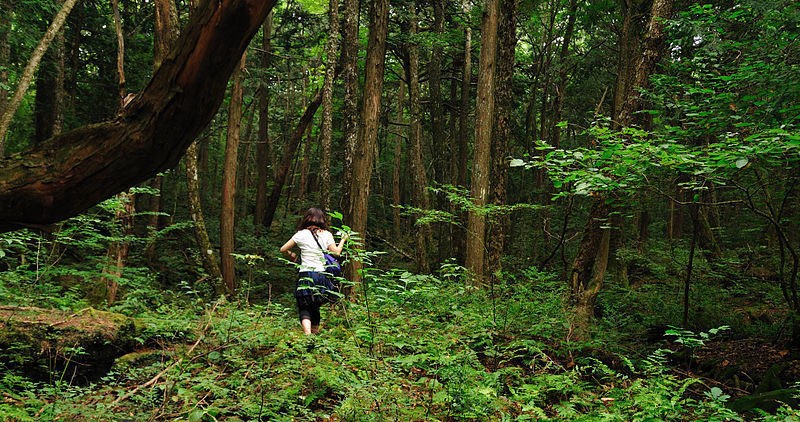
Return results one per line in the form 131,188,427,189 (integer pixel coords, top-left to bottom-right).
0,0,274,232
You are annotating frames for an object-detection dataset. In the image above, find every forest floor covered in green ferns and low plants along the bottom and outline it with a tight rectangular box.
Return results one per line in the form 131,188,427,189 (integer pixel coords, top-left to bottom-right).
0,271,800,421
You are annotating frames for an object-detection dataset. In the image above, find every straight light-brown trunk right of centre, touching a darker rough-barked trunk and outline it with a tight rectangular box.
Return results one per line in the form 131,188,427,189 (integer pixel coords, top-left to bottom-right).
466,0,500,286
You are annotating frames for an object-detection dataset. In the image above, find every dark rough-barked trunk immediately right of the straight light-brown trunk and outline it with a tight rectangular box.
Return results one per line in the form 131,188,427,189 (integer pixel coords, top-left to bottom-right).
487,0,517,284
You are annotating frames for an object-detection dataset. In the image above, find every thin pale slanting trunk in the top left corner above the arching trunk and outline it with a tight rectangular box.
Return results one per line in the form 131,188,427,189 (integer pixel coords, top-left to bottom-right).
0,0,77,151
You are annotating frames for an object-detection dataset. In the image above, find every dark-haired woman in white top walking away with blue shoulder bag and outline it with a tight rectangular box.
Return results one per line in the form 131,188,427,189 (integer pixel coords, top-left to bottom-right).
281,208,347,335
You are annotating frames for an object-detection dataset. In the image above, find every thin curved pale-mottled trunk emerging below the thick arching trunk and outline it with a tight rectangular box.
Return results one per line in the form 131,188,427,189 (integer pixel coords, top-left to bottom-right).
185,142,224,288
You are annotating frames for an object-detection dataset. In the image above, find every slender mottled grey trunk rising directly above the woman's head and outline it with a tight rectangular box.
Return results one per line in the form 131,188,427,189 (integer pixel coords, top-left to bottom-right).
319,0,339,211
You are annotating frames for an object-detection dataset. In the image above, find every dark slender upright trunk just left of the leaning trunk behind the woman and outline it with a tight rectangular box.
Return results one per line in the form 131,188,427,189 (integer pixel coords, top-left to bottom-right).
253,12,275,229
